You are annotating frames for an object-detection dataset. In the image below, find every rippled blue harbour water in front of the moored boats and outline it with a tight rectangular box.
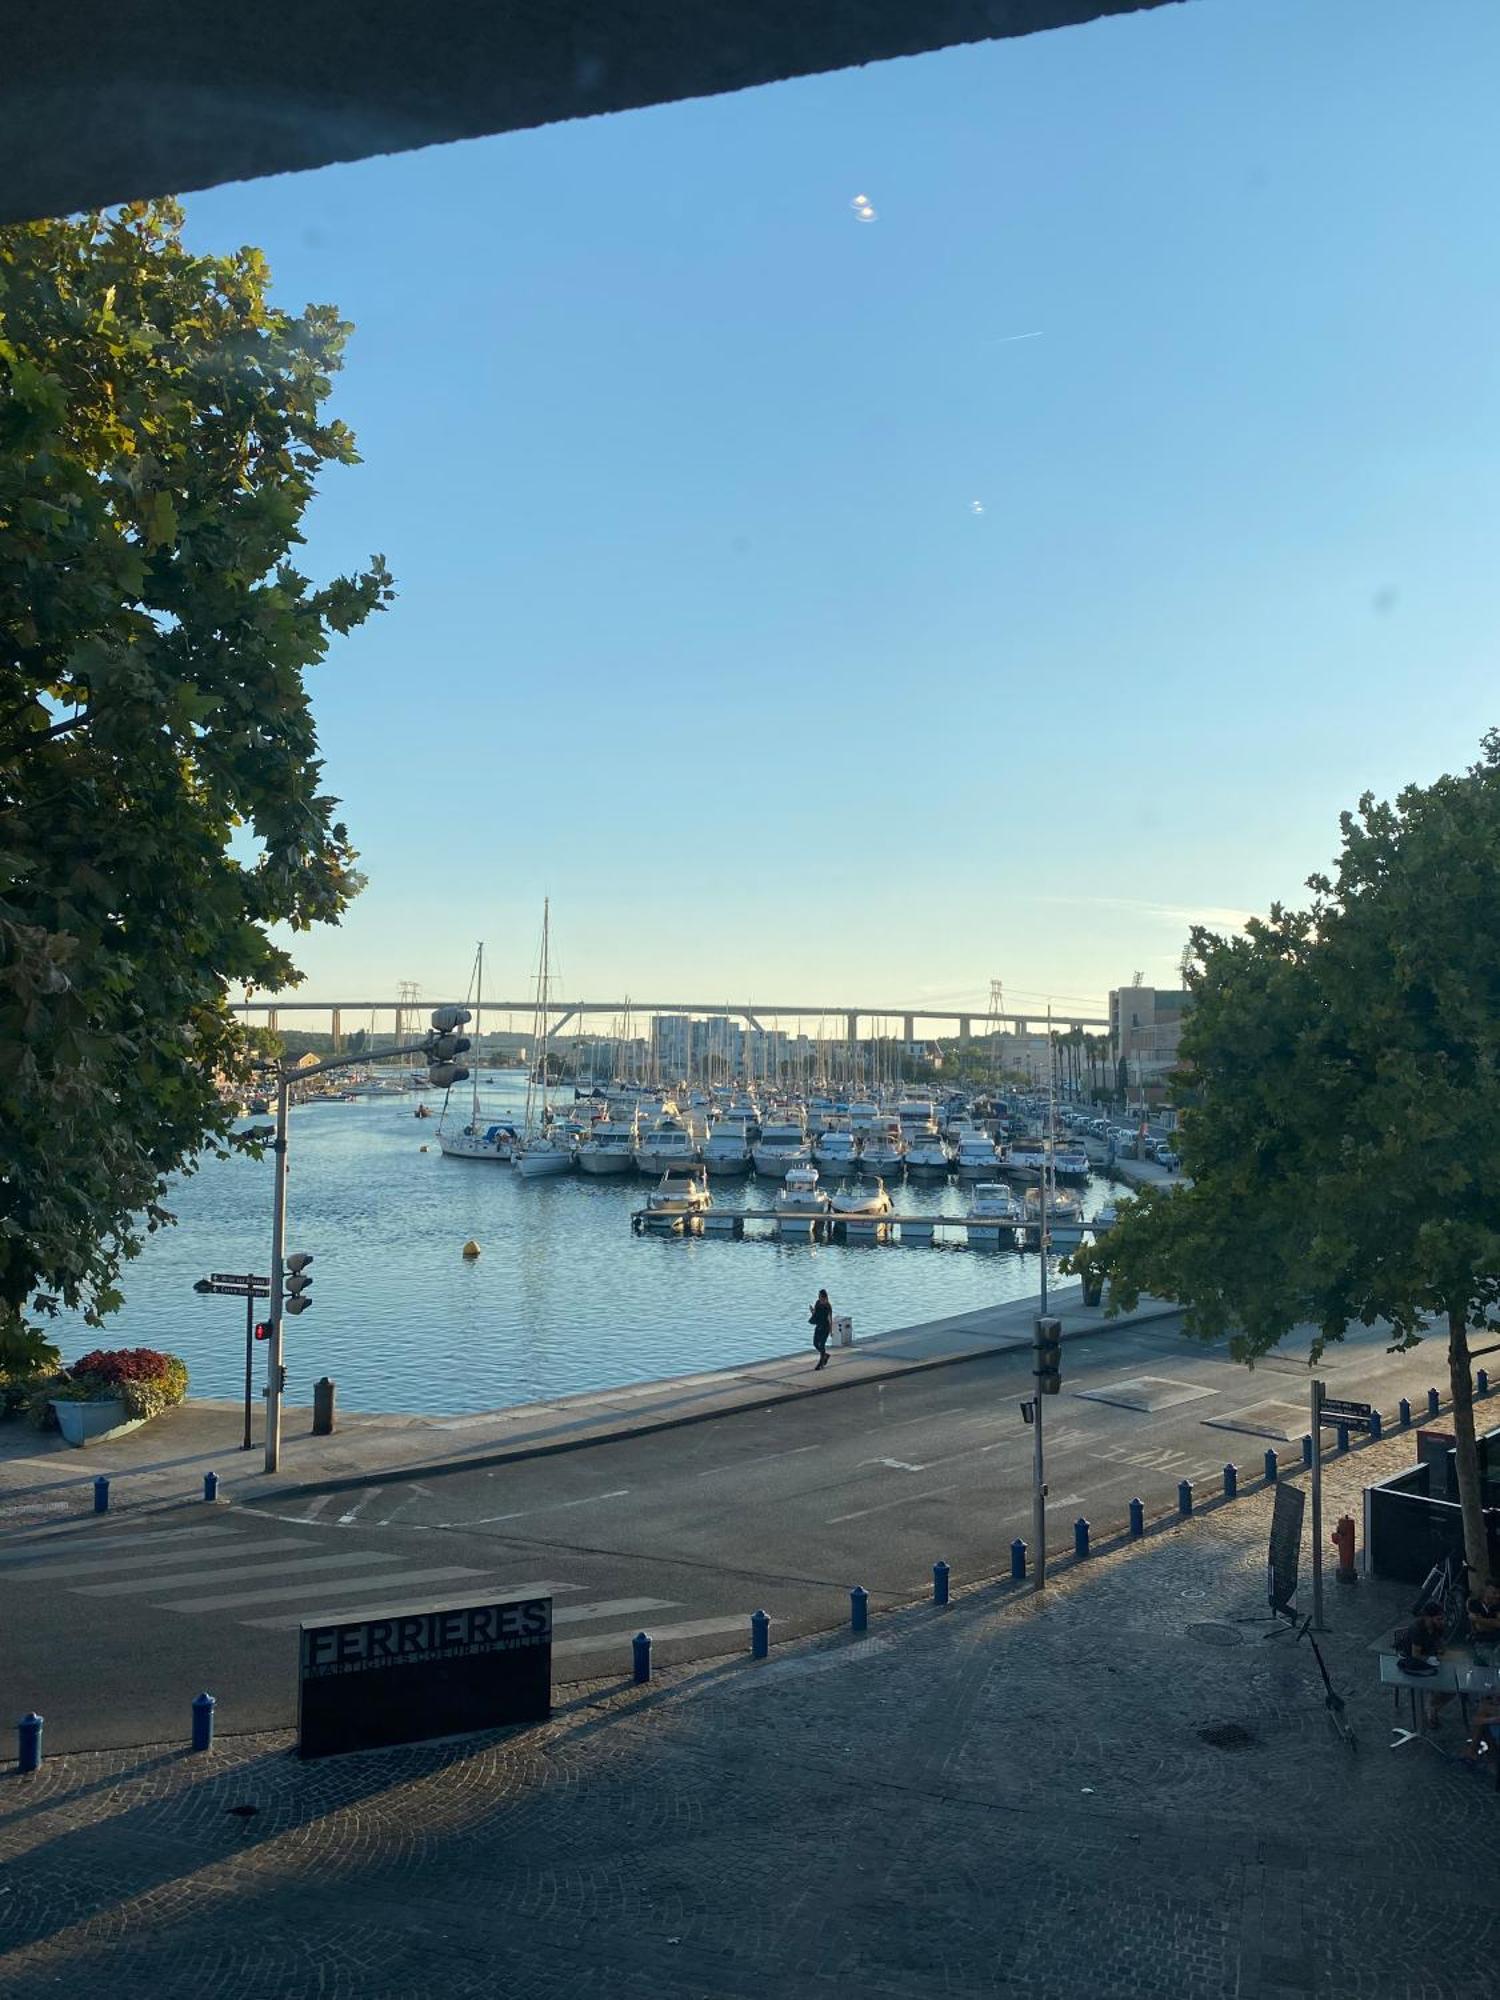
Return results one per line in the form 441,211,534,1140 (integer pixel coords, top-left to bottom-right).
58,1074,1100,1414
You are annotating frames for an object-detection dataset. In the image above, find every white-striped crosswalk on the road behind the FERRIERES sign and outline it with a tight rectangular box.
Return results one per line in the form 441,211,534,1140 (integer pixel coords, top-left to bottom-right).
0,1520,750,1672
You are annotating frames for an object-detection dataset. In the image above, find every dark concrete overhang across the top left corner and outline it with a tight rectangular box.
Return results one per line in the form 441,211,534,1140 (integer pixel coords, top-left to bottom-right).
0,0,1180,222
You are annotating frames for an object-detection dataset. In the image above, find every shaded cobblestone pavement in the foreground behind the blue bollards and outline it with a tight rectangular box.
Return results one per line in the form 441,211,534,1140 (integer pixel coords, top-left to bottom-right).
0,1440,1500,2000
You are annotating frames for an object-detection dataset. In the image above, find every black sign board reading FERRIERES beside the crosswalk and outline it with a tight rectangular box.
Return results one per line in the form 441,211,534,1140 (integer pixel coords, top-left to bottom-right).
296,1598,552,1756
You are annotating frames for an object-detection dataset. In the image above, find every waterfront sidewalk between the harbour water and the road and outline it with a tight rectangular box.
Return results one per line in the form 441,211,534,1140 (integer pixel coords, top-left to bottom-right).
0,1284,1180,1526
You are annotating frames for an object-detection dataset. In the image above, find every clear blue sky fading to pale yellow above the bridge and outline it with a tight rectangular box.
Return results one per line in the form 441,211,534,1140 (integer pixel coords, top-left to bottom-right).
186,0,1500,1012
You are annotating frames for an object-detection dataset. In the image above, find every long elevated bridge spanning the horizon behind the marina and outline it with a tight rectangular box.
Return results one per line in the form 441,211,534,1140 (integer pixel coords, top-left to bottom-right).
232,996,1110,1048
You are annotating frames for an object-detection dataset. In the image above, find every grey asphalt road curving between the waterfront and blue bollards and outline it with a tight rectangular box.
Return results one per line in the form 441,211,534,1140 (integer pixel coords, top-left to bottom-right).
0,1320,1472,1750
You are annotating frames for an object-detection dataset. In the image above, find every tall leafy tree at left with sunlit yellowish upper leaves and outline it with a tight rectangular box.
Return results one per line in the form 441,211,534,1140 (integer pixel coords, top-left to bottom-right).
0,202,392,1368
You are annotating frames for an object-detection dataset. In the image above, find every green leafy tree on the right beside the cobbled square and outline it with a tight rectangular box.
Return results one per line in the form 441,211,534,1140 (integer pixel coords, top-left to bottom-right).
1074,732,1500,1576
